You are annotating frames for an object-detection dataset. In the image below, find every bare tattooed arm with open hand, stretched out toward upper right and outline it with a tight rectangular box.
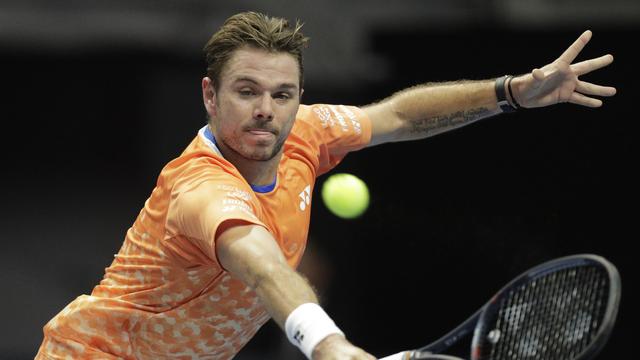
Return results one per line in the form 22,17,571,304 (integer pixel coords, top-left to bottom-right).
364,31,616,146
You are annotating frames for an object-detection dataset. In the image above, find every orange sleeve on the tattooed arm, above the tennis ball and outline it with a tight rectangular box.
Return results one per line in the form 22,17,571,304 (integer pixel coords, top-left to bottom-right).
293,104,371,175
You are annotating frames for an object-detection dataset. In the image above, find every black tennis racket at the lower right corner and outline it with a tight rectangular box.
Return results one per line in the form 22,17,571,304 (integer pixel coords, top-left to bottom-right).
381,254,621,360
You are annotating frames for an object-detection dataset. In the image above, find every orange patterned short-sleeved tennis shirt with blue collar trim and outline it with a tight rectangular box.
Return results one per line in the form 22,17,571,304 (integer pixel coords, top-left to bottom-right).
36,104,371,359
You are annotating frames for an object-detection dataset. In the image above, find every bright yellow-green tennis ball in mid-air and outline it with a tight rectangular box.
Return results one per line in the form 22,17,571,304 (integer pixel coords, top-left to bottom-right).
322,173,369,219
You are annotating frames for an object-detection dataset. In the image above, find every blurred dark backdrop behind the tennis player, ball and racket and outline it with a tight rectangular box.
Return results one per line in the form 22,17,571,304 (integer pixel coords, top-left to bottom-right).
0,0,640,360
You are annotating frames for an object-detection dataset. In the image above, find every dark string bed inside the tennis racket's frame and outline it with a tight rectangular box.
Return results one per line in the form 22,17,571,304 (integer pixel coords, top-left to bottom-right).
479,267,608,360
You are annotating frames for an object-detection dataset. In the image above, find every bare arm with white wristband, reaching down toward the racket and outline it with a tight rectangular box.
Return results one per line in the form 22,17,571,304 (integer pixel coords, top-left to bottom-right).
216,224,374,360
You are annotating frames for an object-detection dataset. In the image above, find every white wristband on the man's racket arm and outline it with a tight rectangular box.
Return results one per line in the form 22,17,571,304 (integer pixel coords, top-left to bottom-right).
284,303,344,359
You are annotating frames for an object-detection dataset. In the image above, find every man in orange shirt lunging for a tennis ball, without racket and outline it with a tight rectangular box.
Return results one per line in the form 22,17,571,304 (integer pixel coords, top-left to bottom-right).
36,12,616,359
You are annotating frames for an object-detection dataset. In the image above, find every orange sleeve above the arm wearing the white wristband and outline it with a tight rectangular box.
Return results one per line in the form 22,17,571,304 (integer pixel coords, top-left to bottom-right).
167,172,266,259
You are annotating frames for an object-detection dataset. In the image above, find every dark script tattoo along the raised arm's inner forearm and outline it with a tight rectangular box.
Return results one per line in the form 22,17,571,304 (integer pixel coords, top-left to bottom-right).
409,107,491,136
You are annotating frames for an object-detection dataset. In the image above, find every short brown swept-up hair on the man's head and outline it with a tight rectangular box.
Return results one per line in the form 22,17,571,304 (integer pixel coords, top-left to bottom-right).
203,12,309,90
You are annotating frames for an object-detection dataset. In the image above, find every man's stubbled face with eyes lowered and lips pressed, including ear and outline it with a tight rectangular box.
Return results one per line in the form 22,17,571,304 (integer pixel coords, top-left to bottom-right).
203,47,301,161
